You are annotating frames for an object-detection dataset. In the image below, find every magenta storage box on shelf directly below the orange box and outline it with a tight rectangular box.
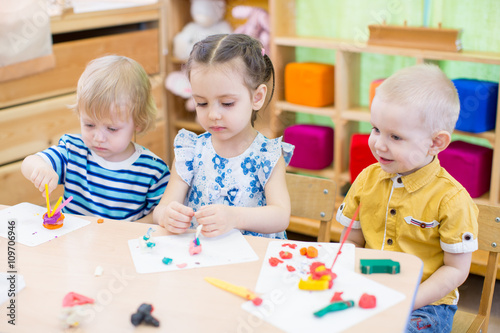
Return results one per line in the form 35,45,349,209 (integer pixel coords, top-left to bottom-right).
283,124,333,170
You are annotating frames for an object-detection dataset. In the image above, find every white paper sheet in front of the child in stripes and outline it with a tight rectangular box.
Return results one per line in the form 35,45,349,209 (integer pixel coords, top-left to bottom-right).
0,202,90,246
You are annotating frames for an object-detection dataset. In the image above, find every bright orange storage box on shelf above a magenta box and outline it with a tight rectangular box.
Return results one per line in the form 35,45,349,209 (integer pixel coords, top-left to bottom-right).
285,62,334,107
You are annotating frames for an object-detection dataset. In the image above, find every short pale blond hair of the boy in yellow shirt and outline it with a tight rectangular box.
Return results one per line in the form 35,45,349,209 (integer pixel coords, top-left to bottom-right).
375,64,460,134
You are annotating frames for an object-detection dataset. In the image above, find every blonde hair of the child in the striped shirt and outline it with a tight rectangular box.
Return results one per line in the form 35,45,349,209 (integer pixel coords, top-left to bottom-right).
72,55,157,134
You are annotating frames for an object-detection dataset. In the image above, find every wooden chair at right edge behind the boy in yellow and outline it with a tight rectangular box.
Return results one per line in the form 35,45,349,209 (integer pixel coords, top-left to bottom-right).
452,204,500,333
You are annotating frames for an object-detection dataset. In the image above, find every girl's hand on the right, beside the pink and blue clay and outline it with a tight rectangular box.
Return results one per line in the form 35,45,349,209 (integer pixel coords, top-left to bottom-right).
194,205,236,237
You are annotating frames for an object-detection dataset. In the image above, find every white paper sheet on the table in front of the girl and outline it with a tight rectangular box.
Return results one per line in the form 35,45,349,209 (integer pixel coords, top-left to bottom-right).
128,230,259,273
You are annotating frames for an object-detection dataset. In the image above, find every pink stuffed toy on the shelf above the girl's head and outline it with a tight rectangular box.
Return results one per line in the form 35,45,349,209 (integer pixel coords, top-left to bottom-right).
232,6,270,54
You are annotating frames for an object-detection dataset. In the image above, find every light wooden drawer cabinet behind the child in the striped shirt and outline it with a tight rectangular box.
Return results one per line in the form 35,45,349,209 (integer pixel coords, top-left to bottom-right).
0,0,167,206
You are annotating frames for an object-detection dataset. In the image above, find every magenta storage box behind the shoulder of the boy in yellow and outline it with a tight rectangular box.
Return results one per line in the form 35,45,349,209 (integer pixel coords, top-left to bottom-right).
439,141,493,198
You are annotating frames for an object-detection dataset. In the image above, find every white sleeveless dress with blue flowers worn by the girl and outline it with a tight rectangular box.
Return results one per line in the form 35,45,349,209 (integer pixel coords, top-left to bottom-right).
174,129,294,239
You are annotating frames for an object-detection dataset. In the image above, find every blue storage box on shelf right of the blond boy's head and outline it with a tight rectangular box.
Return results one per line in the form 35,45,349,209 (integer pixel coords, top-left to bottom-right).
452,79,498,133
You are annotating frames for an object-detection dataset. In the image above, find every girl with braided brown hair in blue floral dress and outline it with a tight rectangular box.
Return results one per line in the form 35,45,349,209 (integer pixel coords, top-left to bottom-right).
154,34,294,239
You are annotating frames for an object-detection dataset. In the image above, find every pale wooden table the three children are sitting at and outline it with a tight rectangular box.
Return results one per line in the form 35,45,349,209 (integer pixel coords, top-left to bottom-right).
0,211,422,333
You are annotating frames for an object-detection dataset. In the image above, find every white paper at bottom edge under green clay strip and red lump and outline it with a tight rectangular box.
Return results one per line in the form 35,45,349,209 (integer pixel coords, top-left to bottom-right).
242,264,405,333
